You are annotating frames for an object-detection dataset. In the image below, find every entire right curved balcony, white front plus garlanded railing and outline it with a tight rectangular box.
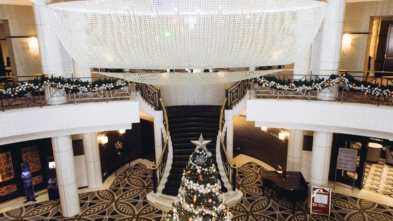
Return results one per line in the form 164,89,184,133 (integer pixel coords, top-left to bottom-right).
247,71,393,139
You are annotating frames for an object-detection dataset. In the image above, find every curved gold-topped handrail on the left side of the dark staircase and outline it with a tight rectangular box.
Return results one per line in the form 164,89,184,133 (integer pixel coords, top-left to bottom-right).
152,98,169,192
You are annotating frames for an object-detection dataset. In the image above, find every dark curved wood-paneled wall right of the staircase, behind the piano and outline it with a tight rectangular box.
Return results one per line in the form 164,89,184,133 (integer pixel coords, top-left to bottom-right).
233,116,288,168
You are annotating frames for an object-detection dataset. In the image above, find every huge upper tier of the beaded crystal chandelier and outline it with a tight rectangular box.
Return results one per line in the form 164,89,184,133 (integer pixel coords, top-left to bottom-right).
47,0,326,69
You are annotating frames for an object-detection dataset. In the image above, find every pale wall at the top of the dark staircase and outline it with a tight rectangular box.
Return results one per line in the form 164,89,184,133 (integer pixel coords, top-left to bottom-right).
159,83,229,106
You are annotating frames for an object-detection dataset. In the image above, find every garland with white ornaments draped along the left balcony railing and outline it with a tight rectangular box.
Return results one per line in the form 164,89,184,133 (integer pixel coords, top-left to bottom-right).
0,77,129,98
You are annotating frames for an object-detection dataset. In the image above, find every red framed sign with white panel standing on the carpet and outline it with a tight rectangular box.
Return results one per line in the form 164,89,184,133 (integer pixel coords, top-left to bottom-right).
310,186,332,216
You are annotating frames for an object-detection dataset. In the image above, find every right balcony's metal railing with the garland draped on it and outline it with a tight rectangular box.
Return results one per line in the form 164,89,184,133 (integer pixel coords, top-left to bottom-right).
251,71,393,105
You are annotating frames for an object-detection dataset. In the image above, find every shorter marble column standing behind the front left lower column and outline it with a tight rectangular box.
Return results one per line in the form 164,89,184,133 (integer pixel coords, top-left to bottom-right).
83,133,102,189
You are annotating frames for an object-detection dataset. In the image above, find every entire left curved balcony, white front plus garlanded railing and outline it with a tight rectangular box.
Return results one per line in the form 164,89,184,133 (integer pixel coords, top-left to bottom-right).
0,76,159,145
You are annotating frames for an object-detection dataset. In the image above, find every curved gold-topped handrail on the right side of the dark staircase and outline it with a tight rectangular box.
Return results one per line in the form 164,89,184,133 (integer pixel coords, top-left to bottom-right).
218,98,237,191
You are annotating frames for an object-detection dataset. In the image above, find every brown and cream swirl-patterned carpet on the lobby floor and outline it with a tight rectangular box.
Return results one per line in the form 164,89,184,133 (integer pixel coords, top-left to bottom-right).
0,163,393,221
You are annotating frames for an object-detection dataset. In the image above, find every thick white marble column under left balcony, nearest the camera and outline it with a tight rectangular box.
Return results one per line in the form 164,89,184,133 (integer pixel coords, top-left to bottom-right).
52,136,80,217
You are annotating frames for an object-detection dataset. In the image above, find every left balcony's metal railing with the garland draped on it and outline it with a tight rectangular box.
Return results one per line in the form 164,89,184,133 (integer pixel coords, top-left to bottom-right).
0,75,160,111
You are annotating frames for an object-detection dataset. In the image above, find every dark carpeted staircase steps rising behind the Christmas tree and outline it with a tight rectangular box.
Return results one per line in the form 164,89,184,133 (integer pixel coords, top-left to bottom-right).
162,106,227,196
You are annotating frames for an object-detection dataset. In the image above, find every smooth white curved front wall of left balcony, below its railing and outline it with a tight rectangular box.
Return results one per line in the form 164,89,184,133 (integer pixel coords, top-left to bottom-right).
0,101,139,145
